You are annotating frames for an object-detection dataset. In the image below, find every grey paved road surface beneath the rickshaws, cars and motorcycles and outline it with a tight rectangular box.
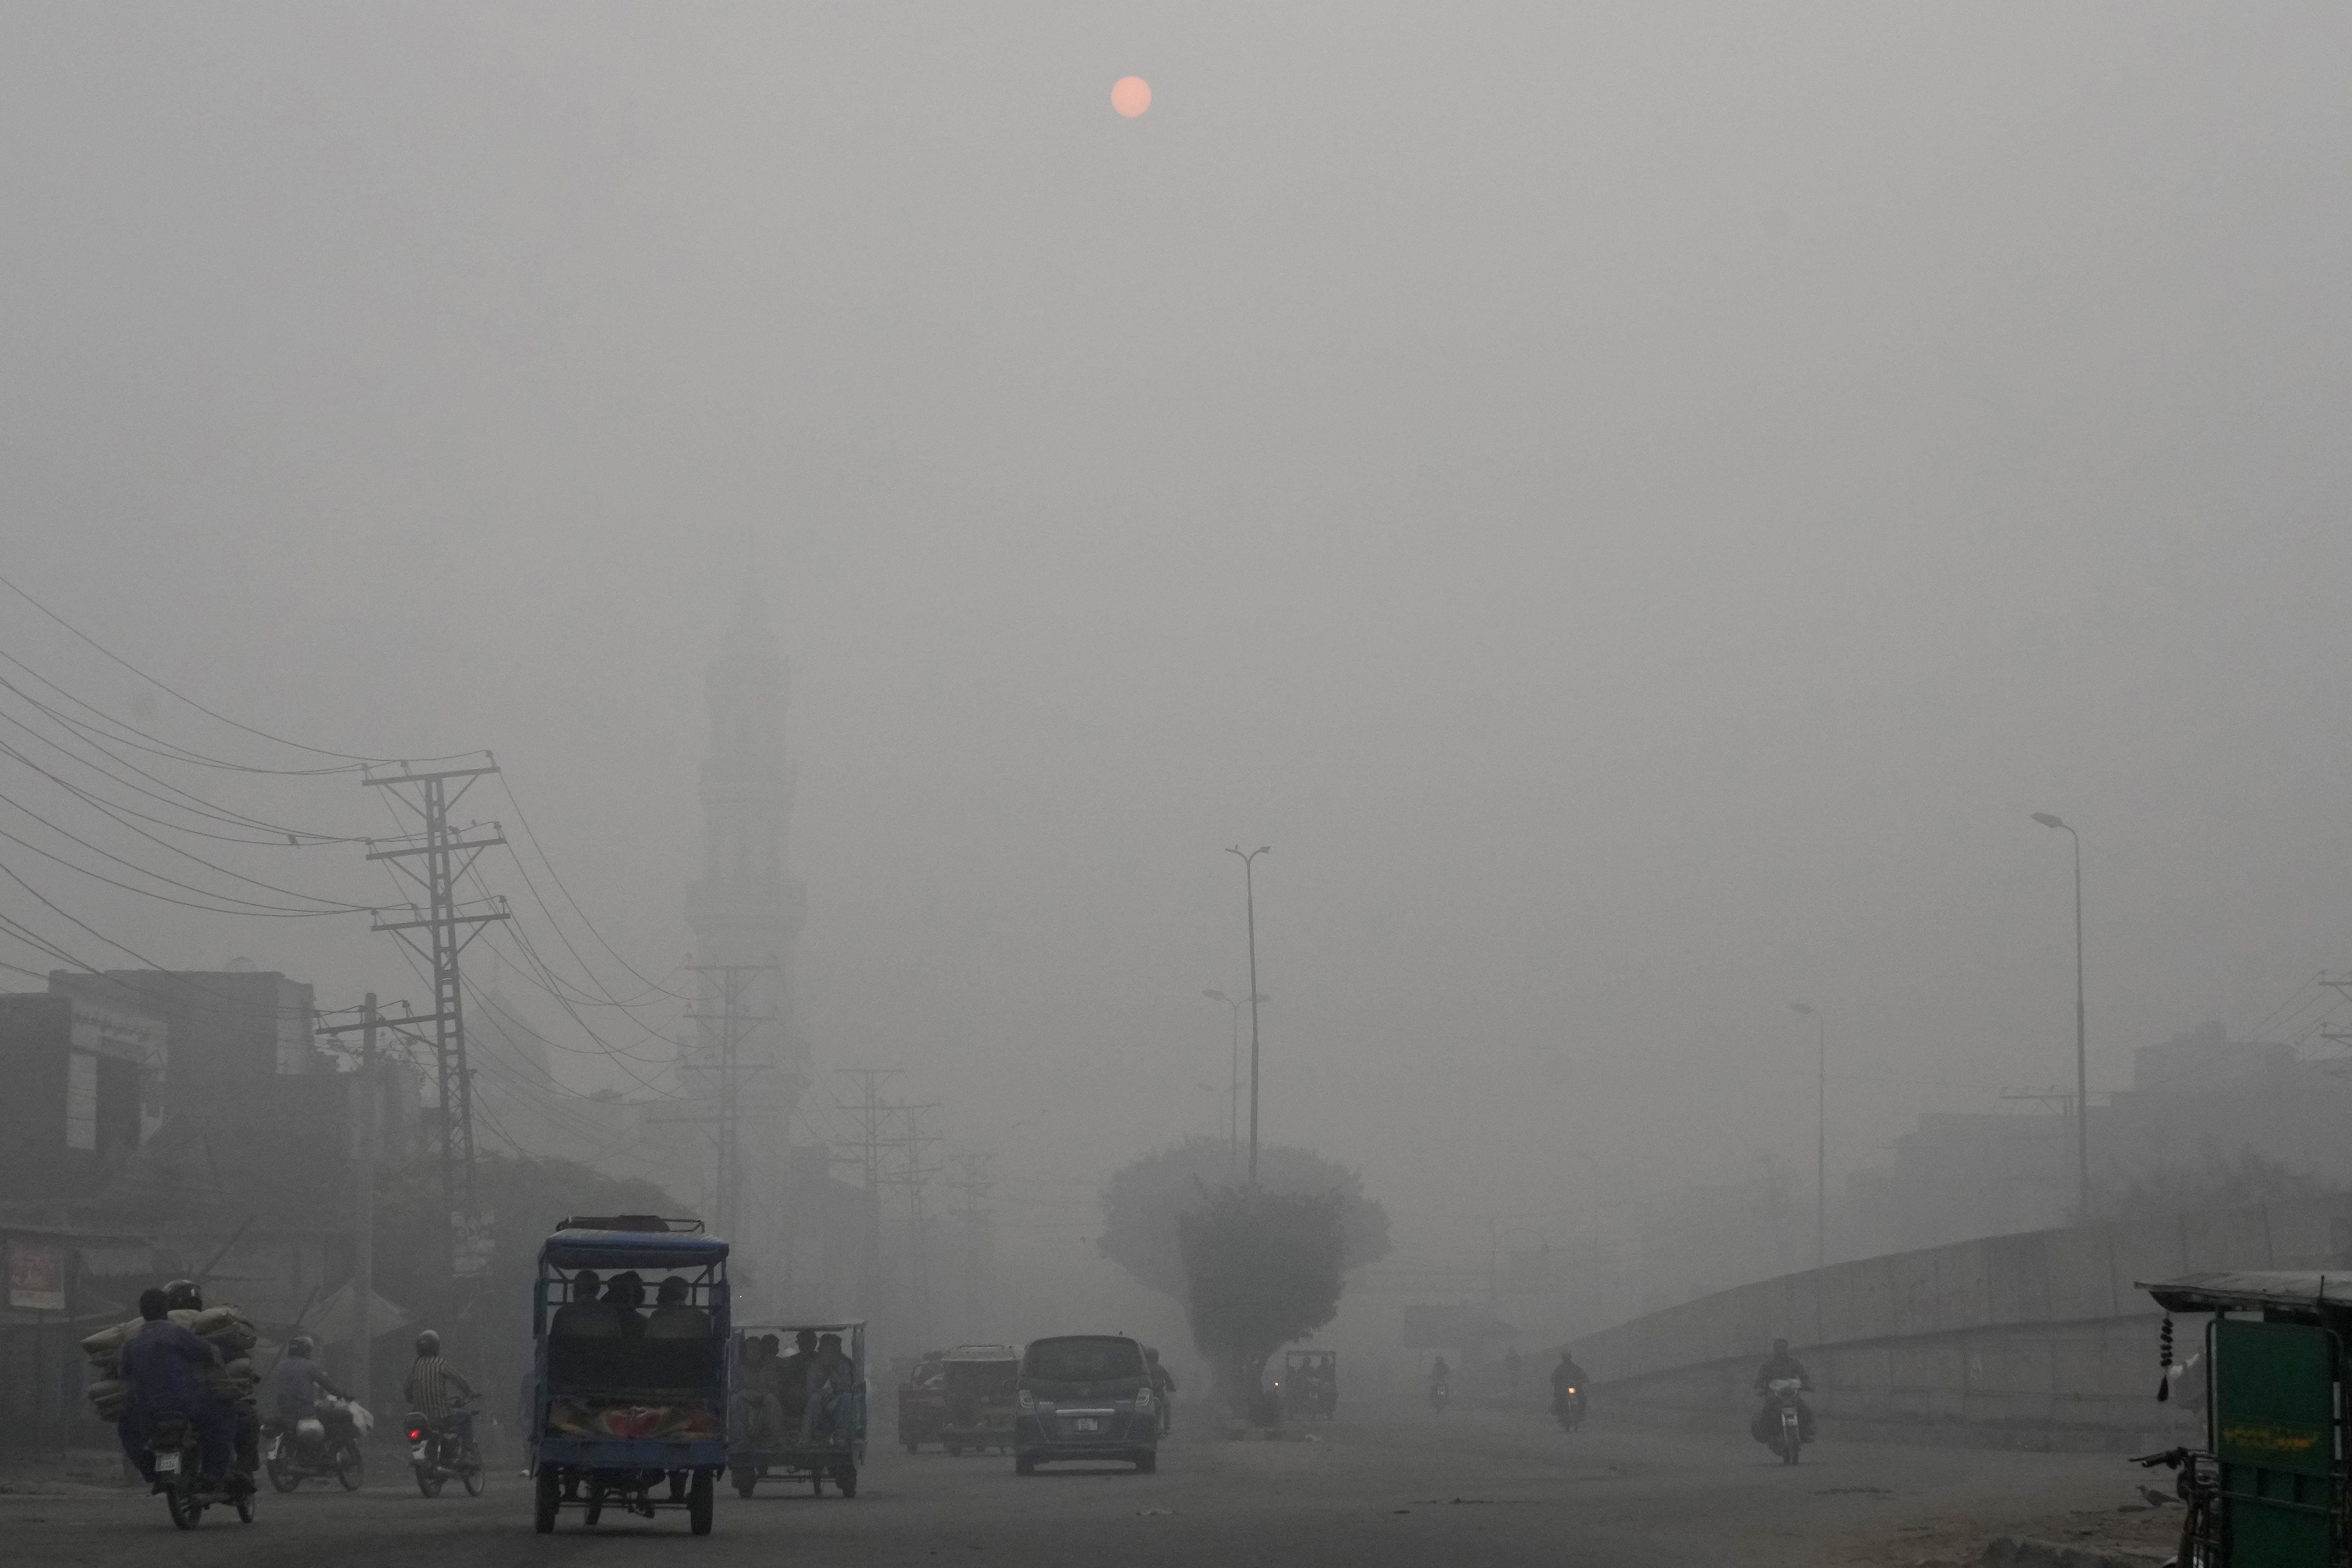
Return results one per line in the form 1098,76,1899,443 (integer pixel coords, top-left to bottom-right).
0,1410,2129,1568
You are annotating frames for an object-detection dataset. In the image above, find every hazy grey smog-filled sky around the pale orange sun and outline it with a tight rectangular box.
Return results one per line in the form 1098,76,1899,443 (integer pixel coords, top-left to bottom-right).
0,0,2352,1250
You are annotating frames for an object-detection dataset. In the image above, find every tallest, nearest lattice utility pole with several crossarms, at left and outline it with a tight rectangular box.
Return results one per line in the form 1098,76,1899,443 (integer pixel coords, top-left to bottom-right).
360,752,510,1279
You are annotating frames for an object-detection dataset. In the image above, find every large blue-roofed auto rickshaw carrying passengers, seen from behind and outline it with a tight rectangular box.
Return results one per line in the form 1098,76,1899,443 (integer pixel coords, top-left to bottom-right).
529,1215,729,1535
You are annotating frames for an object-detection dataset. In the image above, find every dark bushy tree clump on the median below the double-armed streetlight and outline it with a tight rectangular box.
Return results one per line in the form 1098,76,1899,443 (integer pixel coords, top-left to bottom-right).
1096,1138,1388,1408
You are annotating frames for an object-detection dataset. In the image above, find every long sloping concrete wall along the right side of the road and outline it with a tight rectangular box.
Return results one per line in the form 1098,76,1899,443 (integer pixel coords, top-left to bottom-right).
1571,1196,2352,1448
